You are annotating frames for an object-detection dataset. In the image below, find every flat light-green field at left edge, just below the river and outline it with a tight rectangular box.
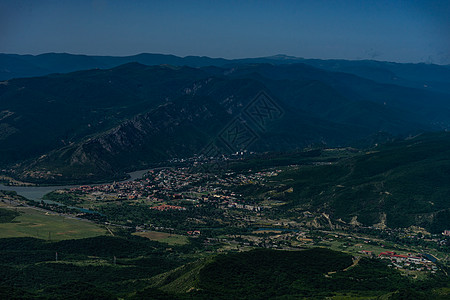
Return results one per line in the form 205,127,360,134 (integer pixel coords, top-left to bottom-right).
0,207,108,241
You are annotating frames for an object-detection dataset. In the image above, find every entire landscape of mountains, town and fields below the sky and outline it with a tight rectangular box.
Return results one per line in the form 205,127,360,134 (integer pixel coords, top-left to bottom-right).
0,54,450,299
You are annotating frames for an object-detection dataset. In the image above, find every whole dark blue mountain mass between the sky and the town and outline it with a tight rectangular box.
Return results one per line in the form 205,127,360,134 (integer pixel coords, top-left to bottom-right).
0,54,450,183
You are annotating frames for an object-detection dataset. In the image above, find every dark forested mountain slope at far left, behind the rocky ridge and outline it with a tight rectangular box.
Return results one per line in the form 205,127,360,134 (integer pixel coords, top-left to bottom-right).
0,64,204,164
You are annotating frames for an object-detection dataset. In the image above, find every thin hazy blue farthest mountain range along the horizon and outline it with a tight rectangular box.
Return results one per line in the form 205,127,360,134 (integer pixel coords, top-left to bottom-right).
0,53,450,92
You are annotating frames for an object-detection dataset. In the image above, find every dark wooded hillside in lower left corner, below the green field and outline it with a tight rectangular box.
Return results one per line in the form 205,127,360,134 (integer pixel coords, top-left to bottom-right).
0,236,187,299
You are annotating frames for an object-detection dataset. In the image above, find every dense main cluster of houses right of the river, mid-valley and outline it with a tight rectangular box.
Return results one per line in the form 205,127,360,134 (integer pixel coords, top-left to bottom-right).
65,168,280,212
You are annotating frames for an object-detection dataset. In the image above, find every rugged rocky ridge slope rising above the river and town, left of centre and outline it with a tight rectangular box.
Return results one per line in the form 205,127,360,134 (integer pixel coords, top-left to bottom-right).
14,78,258,181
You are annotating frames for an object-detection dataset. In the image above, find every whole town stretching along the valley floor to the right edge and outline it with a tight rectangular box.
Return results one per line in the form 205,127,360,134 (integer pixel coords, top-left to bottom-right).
10,159,449,276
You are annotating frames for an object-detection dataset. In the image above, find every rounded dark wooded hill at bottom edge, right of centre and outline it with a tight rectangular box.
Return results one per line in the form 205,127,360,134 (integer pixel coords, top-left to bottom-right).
132,248,446,299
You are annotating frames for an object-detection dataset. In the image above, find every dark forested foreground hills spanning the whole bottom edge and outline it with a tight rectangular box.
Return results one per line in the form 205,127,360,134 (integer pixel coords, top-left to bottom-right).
0,236,448,299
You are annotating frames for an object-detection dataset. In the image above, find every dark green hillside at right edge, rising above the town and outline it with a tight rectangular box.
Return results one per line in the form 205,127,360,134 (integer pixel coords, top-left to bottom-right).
241,133,450,233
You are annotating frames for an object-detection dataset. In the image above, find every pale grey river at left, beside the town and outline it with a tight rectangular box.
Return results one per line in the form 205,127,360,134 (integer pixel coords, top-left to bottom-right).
0,169,152,201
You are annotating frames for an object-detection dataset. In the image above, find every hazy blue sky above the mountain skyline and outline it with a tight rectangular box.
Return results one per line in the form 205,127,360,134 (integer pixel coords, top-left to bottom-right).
0,0,450,64
